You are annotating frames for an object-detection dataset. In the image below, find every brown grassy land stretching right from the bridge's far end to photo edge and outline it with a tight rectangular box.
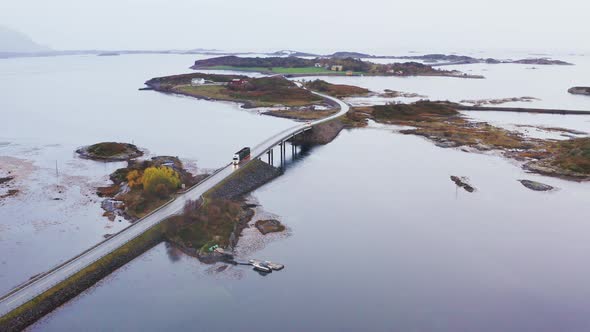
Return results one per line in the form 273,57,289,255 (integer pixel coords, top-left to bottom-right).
347,101,590,179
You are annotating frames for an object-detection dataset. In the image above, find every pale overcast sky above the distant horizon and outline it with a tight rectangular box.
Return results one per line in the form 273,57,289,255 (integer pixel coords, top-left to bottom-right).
0,0,590,53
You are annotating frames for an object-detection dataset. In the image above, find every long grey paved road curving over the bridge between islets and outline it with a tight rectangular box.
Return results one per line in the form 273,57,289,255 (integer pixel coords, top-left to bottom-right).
0,83,349,316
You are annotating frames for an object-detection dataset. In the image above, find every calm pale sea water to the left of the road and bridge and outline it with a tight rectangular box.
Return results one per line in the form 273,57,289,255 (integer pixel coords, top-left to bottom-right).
0,55,292,292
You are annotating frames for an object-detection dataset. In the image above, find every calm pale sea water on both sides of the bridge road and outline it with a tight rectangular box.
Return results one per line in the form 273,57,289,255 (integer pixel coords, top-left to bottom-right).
0,55,590,331
